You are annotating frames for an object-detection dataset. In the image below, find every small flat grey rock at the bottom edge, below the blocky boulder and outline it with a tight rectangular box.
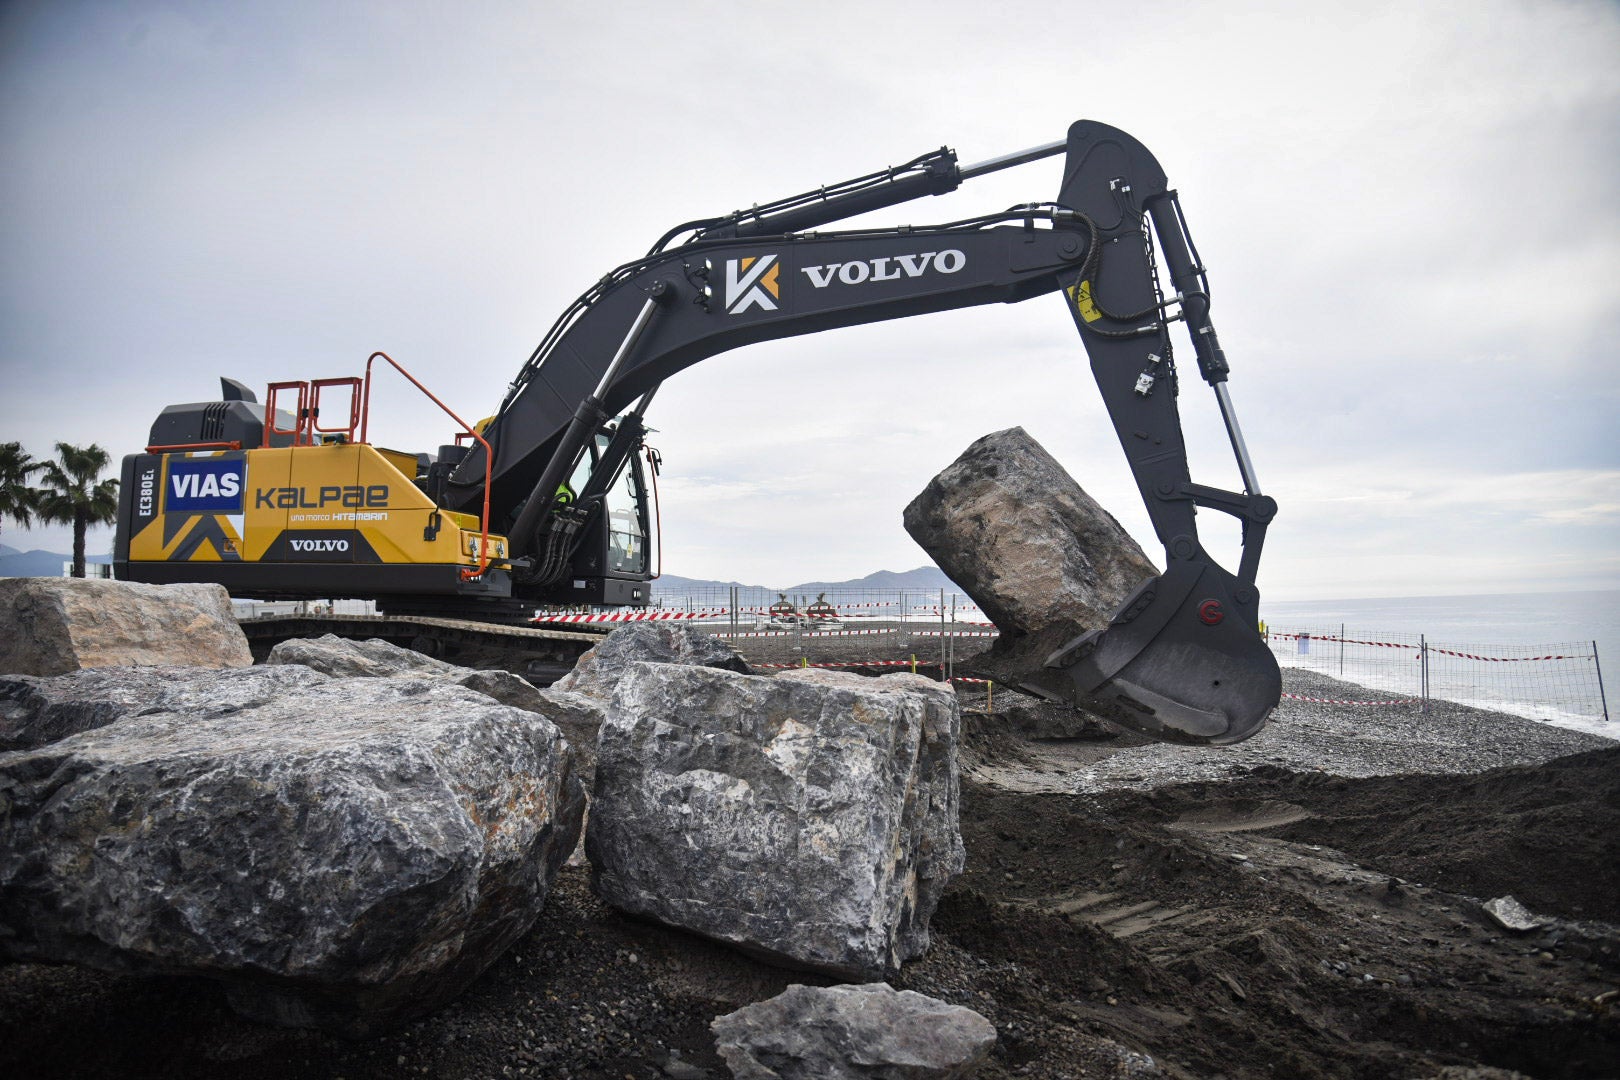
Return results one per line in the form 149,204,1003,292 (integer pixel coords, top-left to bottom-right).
710,983,996,1080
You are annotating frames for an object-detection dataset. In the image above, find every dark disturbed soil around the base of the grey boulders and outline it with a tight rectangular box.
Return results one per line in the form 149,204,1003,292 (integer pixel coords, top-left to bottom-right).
0,628,1620,1080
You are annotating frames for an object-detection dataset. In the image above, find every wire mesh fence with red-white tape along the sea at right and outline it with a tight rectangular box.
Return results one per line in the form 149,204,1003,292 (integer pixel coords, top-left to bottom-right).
1264,625,1609,721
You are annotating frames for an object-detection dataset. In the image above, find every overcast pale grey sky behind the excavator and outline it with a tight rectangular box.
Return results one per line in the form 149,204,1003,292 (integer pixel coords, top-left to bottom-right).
0,0,1620,599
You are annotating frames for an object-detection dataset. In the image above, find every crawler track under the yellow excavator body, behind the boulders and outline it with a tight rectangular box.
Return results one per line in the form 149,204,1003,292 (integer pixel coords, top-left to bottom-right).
240,615,606,685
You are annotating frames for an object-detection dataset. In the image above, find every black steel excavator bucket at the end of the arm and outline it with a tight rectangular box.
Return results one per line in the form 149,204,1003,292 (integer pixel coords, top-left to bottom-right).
1030,560,1283,746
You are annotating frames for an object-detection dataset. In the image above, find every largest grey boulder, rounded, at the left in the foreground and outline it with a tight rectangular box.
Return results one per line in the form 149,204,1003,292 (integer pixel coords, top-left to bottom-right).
0,665,583,1036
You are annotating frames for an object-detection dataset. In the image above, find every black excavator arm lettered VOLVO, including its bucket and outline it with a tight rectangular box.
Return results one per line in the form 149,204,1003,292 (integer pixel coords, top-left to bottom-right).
449,121,1281,743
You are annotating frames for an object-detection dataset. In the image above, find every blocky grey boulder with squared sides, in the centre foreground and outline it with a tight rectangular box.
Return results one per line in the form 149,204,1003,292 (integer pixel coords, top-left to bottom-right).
585,664,962,978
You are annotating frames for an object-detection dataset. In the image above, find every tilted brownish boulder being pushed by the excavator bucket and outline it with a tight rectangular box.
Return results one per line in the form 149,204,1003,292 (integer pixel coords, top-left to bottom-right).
904,427,1158,696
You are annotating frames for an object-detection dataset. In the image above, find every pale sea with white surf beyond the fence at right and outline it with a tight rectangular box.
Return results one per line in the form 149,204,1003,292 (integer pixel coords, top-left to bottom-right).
1260,589,1620,738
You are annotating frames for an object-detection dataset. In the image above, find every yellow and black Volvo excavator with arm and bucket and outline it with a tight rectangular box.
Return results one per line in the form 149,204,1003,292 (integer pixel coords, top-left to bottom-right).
113,120,1281,745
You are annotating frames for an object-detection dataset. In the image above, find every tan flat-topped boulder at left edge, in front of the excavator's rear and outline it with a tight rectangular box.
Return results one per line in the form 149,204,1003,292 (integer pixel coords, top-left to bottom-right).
0,578,253,675
